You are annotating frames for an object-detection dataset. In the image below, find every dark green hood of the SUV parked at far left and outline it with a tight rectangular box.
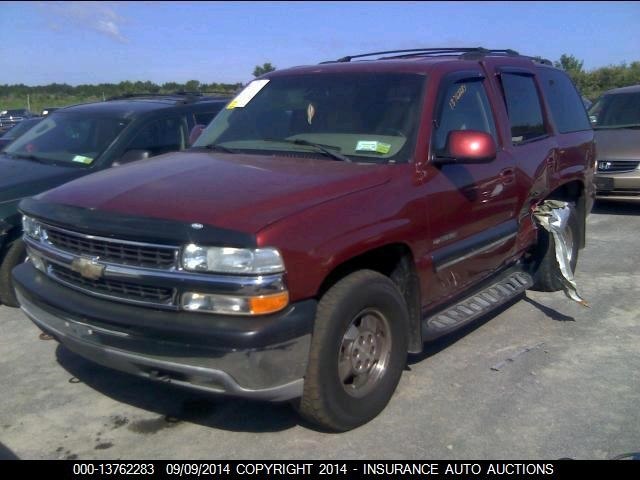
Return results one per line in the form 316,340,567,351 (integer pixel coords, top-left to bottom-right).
0,154,88,203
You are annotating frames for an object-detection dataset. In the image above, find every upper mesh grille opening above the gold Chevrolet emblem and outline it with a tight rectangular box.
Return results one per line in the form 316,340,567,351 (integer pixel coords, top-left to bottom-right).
45,226,177,270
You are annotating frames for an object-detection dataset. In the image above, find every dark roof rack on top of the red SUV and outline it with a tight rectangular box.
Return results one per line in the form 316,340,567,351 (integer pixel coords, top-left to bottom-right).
321,47,551,65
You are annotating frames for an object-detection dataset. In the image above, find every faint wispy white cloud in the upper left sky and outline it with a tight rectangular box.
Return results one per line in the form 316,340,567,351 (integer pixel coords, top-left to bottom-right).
39,2,129,43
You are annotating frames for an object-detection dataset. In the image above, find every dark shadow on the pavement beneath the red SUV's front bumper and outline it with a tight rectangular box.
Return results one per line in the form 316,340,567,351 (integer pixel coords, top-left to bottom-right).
56,345,321,434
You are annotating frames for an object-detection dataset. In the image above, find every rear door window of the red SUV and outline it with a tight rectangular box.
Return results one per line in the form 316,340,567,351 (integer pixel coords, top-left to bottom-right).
501,73,546,144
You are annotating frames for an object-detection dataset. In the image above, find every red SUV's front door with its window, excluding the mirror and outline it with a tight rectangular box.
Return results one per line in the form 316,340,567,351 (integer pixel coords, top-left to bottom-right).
427,70,518,303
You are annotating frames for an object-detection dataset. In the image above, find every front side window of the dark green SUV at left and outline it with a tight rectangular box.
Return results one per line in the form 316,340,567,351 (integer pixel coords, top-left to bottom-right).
127,117,187,156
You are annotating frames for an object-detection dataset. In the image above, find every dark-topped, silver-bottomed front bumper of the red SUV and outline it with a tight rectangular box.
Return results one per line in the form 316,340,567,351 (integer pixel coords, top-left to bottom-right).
13,263,316,401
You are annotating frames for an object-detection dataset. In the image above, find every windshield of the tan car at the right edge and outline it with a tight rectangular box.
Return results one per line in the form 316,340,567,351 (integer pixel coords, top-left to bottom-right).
589,92,640,129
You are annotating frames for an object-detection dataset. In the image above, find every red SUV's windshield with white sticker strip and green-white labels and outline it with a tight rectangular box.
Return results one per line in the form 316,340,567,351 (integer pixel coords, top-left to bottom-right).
194,73,425,162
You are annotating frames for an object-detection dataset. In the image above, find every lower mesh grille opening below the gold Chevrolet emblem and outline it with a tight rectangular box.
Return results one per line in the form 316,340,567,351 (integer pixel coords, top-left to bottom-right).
49,264,174,305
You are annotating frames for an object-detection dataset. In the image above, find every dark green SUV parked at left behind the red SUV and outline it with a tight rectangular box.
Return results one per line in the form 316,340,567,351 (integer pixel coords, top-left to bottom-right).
0,94,228,306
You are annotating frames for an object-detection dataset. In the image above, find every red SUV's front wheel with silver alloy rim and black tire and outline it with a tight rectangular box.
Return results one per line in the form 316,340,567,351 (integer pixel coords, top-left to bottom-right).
298,270,409,431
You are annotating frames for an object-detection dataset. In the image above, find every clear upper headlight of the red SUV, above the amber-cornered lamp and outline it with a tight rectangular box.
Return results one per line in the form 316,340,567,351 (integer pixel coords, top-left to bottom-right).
182,243,284,275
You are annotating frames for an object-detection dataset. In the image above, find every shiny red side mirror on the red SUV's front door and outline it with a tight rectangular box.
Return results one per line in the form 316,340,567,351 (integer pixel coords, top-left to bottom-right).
434,130,497,164
